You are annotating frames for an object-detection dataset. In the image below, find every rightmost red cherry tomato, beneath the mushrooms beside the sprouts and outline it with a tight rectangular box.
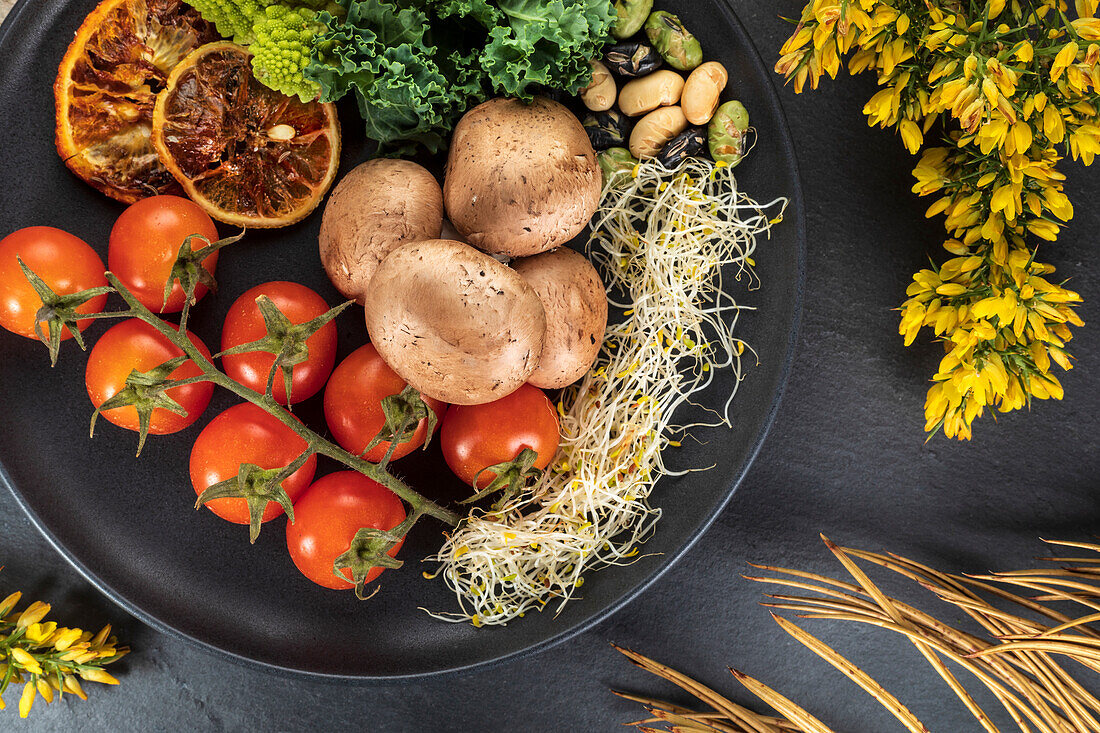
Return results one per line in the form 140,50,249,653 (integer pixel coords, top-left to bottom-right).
440,384,561,489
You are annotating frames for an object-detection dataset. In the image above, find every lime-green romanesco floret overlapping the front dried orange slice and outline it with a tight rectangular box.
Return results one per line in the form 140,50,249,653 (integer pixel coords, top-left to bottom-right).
249,6,325,102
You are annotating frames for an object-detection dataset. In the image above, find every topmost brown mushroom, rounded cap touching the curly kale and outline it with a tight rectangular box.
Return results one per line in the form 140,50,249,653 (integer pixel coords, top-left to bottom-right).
443,97,603,256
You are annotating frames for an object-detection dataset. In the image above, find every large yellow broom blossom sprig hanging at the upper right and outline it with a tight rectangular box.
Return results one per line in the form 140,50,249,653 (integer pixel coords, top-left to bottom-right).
776,0,1100,439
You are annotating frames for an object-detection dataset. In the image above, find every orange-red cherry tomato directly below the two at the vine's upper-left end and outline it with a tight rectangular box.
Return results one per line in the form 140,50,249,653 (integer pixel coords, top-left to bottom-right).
85,318,213,435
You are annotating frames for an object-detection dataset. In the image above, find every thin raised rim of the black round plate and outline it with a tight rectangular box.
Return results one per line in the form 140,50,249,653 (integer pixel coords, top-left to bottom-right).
0,0,806,686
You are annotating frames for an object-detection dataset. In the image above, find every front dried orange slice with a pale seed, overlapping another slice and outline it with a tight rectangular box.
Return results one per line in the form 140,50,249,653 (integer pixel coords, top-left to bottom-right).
153,41,340,228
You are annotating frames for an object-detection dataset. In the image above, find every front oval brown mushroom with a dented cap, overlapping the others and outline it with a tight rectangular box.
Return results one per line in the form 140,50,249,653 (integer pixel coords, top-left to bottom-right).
366,239,547,405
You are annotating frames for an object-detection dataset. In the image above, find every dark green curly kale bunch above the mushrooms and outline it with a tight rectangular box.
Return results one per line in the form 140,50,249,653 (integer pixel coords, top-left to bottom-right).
305,0,614,154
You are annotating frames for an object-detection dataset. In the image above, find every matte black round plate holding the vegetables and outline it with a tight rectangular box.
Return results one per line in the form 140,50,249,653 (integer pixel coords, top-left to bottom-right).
0,0,805,679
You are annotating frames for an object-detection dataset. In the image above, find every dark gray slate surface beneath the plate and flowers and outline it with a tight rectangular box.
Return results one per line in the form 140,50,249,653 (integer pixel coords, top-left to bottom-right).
0,0,1100,732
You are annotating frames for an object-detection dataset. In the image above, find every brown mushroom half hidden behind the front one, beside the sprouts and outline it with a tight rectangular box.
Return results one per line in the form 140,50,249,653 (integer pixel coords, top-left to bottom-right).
512,247,607,390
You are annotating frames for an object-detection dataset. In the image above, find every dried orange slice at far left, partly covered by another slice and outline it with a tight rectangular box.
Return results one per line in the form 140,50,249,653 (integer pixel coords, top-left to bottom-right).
54,0,218,204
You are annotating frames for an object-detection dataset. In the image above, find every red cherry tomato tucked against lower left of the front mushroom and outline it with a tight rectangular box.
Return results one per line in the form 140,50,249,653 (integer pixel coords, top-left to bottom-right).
325,343,447,462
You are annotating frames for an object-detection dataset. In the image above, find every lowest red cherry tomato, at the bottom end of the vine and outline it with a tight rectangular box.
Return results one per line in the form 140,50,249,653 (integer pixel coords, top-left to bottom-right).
286,471,405,590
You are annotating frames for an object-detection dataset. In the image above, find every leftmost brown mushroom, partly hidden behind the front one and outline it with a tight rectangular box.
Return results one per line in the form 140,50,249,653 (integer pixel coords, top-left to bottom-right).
318,158,443,304
